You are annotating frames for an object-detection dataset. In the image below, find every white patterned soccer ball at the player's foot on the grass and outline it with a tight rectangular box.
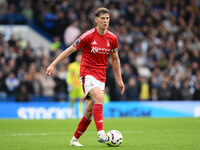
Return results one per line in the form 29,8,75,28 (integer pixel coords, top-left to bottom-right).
106,130,123,146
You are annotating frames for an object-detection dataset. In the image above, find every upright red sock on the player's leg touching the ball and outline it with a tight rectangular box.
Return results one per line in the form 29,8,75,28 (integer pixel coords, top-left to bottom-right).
93,104,103,131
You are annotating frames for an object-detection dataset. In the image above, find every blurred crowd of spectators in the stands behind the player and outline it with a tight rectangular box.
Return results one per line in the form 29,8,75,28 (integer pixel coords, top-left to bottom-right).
0,0,200,101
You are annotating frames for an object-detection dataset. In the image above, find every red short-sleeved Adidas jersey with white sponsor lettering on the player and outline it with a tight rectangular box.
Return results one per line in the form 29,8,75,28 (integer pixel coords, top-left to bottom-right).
73,28,118,82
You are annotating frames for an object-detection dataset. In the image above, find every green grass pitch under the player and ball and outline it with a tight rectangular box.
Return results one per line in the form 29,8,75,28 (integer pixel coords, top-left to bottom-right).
0,118,200,150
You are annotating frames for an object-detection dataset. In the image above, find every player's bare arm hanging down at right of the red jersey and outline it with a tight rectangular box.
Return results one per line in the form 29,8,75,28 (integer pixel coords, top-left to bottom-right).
110,52,124,94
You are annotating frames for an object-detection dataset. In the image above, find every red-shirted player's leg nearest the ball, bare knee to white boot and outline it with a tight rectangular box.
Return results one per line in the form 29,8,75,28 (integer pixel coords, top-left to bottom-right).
89,87,107,143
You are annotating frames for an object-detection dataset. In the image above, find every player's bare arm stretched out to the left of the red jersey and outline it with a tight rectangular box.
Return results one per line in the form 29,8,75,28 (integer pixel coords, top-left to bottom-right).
45,45,77,77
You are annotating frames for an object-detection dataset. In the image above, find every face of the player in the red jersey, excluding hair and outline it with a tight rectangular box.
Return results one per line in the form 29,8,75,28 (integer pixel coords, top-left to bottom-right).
95,13,110,30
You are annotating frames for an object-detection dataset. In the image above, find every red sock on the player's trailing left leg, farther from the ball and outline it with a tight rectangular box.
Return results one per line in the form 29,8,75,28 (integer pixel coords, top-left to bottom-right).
74,116,92,139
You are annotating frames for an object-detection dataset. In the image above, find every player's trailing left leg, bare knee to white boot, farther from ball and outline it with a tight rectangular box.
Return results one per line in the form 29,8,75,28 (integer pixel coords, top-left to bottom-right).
70,99,94,146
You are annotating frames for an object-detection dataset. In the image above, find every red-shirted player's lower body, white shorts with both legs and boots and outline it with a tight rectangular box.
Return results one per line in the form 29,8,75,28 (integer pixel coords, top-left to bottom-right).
70,76,106,146
